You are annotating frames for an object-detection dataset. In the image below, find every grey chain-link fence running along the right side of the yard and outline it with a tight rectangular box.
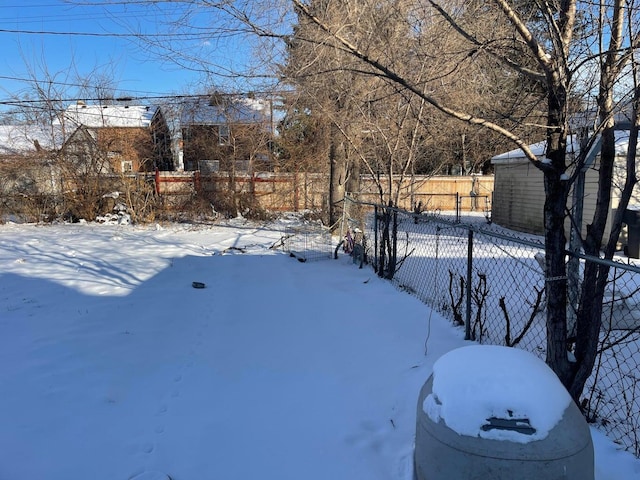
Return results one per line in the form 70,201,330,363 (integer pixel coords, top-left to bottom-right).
342,194,640,456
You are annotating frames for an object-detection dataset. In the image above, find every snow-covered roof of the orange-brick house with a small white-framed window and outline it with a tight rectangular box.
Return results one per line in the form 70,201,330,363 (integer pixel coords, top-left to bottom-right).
58,103,155,128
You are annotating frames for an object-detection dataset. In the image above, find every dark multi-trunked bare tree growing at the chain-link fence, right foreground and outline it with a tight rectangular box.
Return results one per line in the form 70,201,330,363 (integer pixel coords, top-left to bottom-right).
286,0,638,400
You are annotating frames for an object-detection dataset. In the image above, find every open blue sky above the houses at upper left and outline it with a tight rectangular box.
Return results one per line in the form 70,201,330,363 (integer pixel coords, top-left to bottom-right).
0,0,268,111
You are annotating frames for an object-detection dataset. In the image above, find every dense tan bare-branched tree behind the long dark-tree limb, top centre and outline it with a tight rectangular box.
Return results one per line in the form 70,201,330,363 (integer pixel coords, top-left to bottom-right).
283,0,543,213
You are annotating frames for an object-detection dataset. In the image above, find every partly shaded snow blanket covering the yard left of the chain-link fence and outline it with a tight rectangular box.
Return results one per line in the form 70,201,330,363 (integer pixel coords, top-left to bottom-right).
0,219,640,480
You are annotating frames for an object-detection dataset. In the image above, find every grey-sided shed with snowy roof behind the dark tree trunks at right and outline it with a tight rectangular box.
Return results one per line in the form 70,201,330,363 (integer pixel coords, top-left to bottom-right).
491,130,640,244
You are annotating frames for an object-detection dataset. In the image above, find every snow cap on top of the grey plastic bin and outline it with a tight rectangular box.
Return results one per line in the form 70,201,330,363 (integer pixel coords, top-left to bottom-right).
423,345,571,443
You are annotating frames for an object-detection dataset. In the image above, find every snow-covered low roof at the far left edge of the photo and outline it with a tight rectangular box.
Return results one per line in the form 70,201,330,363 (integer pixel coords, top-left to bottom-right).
0,125,62,155
